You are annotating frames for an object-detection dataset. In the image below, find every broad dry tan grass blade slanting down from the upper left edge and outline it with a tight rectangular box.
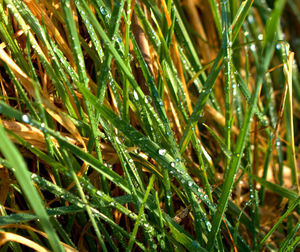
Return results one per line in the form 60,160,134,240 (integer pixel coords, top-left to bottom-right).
0,43,86,149
